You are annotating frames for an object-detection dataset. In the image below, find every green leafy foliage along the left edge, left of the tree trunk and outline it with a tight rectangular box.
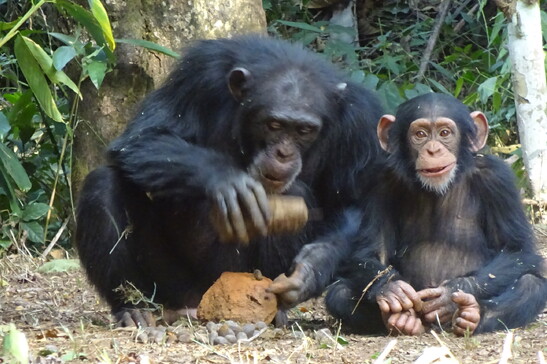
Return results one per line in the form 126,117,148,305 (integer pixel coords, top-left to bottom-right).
0,0,119,250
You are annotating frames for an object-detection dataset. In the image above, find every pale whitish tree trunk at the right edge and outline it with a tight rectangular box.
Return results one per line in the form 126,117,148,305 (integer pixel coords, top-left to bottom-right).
497,0,547,201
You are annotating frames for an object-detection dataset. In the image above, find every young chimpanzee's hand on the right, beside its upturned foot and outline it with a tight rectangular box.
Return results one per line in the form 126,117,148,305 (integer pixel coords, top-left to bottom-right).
418,286,457,324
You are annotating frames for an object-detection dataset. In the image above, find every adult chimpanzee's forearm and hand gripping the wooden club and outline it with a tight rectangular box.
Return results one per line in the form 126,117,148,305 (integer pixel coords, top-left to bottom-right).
109,126,270,242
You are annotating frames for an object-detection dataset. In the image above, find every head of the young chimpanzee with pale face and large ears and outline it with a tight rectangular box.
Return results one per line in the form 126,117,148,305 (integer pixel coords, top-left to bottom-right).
378,94,488,194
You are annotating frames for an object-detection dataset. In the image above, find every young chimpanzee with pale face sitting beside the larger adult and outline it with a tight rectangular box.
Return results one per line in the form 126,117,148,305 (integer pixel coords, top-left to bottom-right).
326,93,547,335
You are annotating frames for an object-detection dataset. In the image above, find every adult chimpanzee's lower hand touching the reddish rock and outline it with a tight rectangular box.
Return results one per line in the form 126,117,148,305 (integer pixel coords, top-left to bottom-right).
268,263,313,308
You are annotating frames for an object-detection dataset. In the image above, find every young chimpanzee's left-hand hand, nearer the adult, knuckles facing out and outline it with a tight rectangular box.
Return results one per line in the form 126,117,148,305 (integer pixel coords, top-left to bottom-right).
376,281,422,314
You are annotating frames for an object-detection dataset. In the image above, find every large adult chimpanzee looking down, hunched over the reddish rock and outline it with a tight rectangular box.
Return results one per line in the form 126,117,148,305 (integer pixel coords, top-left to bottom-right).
76,36,382,325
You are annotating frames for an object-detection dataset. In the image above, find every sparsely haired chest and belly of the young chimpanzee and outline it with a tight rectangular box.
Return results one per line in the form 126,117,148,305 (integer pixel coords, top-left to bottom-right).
393,189,487,289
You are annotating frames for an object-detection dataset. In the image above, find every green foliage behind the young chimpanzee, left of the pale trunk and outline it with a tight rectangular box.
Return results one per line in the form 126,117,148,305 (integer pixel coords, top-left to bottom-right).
264,0,536,182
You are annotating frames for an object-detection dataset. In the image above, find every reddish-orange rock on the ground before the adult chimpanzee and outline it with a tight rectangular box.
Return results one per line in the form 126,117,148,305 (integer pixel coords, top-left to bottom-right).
197,272,277,323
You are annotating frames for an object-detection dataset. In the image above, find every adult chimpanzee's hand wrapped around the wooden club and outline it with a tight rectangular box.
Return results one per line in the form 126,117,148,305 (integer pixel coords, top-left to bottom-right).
206,172,270,243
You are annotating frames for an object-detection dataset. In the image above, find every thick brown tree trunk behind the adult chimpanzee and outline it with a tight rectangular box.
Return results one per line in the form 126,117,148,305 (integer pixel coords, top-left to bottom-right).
72,0,266,196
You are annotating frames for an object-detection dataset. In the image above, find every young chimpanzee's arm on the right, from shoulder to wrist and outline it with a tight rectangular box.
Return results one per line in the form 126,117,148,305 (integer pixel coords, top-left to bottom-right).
449,156,542,299
